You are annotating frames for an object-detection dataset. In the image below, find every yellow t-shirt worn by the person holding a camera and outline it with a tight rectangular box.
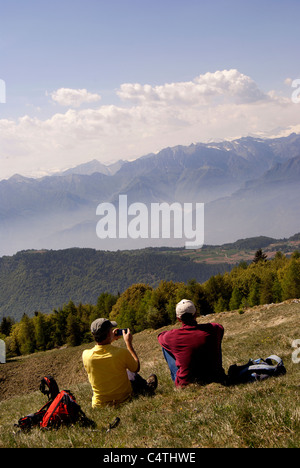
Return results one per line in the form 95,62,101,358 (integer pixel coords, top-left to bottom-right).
82,344,138,408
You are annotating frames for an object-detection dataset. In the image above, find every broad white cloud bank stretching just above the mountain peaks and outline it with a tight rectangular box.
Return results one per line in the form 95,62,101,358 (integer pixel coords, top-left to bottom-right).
0,70,300,178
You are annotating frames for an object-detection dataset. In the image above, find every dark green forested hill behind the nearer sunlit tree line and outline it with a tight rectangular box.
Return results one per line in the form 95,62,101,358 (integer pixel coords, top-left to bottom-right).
0,249,231,320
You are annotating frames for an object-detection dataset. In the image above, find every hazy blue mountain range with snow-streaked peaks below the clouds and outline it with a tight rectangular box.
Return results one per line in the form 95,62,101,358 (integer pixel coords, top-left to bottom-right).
0,134,300,256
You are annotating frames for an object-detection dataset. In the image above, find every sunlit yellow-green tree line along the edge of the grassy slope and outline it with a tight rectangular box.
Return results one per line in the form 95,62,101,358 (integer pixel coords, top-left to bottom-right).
0,249,300,357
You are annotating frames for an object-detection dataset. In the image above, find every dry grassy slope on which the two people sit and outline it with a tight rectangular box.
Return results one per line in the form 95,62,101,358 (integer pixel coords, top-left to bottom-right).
0,301,300,448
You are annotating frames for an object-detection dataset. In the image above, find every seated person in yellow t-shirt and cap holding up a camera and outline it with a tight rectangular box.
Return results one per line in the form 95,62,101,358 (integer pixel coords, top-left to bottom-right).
82,318,157,408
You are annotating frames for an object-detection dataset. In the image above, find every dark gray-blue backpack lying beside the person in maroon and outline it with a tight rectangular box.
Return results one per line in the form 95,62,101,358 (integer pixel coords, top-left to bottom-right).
228,354,286,385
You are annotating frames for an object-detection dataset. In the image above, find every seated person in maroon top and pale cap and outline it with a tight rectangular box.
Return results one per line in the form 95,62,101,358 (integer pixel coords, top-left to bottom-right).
158,299,225,387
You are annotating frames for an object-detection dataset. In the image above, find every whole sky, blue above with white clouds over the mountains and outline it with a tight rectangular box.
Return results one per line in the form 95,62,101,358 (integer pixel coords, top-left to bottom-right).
0,0,300,179
